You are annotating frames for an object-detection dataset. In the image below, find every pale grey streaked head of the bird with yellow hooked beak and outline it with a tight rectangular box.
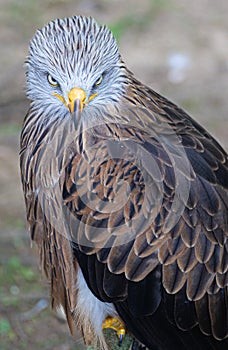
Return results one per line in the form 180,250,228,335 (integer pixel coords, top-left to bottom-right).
26,16,127,121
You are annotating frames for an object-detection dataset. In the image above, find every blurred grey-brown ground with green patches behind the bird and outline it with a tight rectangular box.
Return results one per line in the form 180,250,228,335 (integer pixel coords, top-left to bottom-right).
0,0,228,350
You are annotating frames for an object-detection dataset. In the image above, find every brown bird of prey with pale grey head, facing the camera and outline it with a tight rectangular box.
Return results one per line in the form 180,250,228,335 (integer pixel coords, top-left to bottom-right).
20,16,228,350
